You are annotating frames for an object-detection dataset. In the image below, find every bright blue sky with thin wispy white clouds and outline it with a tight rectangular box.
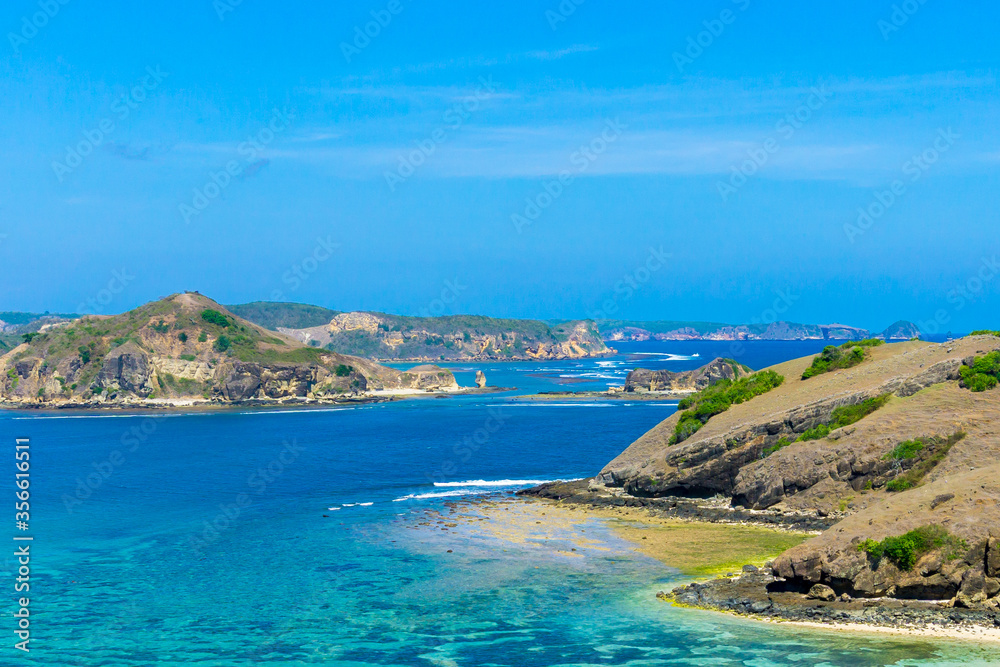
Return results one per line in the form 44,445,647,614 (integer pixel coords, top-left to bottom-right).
0,0,1000,331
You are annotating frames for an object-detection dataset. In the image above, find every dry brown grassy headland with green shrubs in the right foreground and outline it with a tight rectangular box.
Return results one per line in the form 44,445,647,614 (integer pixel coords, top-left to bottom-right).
592,336,1000,607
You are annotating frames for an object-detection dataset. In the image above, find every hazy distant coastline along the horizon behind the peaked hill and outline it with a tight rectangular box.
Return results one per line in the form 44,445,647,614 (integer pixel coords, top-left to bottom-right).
0,301,920,363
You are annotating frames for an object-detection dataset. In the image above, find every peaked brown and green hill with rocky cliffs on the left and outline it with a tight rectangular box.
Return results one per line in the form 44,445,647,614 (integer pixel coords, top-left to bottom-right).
0,293,458,407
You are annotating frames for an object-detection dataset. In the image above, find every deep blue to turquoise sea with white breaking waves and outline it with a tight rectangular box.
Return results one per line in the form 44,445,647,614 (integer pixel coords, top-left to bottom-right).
0,342,1000,667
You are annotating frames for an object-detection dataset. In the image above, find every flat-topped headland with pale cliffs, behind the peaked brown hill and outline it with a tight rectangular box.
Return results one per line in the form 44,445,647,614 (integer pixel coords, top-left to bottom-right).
279,312,614,361
